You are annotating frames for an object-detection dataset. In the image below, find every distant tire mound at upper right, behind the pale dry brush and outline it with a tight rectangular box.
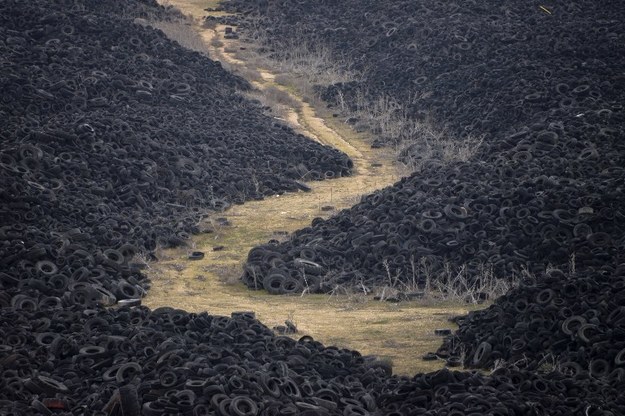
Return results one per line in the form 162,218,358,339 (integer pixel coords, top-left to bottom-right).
224,0,625,147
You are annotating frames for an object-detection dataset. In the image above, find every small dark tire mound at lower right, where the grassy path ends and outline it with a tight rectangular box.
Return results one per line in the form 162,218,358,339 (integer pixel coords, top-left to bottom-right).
439,264,625,384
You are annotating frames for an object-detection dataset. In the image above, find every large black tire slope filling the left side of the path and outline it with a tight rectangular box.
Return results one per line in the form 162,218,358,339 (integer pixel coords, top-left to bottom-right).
0,0,351,309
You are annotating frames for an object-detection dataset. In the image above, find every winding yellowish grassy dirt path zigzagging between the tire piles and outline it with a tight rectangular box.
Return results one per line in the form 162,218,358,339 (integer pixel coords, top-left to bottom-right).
144,0,478,375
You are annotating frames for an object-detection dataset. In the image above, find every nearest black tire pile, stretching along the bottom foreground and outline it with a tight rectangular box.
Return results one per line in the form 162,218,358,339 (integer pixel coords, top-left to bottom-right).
0,306,625,416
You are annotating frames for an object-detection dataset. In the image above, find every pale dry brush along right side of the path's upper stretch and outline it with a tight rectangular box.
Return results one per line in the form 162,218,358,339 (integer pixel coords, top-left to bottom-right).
222,16,483,174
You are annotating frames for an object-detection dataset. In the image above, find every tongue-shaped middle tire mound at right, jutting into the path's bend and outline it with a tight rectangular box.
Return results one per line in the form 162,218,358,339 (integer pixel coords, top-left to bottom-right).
243,156,625,293
